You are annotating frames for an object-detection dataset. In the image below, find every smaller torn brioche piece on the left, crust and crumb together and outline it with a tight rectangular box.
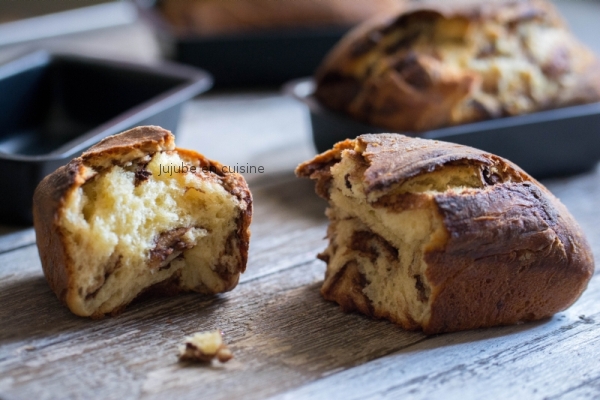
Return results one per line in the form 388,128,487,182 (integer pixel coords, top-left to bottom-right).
33,126,252,317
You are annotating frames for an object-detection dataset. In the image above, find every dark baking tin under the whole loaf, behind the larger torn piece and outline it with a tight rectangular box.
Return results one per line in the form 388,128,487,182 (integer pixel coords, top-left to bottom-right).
283,78,600,178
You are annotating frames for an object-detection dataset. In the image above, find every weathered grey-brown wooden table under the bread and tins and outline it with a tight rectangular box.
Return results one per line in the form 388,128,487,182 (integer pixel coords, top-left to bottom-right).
0,2,600,400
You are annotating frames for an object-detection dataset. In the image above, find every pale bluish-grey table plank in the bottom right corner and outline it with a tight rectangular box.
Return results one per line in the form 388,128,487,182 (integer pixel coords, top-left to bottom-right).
274,275,600,399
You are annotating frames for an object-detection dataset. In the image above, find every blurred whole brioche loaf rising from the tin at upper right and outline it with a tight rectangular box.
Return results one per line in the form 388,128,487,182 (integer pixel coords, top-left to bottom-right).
316,0,600,132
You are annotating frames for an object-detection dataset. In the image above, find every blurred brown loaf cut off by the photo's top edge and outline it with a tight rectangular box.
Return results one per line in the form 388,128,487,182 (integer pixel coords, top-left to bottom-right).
160,0,403,35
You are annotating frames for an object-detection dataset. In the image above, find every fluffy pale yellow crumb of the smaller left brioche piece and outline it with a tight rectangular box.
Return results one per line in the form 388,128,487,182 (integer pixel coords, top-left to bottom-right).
61,152,239,315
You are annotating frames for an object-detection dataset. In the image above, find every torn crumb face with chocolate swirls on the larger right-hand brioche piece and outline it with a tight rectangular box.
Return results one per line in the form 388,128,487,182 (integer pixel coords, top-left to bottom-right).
325,152,482,327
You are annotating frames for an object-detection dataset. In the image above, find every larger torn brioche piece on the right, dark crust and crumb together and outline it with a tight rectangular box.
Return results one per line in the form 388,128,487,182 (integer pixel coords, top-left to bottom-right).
296,134,594,334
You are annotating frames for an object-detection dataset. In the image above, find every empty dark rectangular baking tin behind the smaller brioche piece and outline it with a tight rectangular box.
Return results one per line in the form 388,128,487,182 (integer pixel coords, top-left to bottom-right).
0,52,212,223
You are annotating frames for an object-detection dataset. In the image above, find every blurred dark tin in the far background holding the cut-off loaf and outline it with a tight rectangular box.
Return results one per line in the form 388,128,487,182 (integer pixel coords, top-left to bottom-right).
136,0,350,88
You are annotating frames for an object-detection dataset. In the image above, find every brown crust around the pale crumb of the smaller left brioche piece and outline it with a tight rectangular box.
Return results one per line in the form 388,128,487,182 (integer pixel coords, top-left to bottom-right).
33,126,252,317
